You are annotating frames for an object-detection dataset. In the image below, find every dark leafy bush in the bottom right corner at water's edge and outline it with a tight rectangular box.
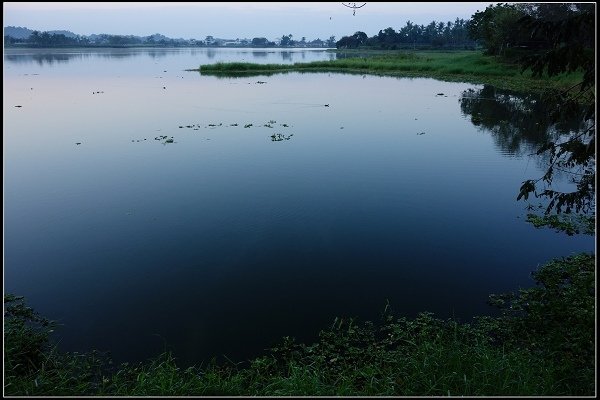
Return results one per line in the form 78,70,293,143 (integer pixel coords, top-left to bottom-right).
490,253,596,391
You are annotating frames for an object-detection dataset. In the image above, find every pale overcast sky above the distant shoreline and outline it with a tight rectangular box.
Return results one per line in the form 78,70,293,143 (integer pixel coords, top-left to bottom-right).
3,2,493,40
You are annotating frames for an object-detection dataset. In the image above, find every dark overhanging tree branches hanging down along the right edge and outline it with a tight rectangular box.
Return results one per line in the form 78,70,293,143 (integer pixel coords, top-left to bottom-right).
517,5,596,214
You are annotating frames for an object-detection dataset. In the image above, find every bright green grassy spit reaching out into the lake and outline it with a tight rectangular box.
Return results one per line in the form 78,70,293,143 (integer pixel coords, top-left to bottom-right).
198,51,582,91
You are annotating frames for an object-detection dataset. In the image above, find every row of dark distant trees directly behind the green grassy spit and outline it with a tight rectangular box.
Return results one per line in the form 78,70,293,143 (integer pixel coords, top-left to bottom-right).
336,18,476,50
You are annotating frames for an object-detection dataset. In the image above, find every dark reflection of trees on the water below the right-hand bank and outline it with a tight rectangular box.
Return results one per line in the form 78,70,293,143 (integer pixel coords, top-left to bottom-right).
460,85,584,155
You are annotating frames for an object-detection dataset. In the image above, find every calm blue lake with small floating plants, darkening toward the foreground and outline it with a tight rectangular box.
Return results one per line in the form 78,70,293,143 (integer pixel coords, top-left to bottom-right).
3,48,595,364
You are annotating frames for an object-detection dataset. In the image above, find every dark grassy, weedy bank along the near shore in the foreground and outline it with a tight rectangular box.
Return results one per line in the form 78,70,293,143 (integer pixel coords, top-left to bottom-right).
4,254,595,396
